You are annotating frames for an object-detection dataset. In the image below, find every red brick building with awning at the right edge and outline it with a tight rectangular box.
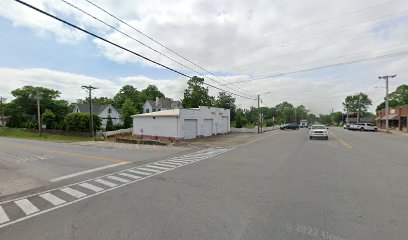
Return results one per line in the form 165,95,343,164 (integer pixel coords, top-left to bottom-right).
375,105,408,132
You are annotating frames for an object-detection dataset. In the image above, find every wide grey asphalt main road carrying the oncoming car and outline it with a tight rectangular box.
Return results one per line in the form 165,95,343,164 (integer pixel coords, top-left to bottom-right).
0,128,408,240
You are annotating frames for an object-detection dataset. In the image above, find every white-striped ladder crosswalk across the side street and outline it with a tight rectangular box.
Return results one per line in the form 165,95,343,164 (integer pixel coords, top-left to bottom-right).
0,148,232,229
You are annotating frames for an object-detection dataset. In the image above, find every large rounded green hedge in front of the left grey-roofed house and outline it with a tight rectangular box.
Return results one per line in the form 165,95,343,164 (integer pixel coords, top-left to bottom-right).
64,113,102,132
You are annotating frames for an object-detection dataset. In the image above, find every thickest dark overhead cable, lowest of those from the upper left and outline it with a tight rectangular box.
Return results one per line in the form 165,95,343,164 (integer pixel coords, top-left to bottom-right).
14,0,255,100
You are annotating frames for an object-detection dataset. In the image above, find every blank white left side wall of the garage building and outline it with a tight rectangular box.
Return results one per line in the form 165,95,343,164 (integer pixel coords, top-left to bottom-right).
133,117,178,138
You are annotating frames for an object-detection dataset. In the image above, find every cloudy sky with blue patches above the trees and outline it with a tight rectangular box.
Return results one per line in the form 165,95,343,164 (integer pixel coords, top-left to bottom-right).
0,0,408,113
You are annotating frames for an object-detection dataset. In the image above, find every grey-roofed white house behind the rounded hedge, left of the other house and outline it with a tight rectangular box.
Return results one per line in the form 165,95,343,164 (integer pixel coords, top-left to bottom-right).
73,104,122,128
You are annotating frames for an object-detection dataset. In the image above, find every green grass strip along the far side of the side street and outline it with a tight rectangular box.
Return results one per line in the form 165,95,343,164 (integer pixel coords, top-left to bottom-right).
0,127,92,142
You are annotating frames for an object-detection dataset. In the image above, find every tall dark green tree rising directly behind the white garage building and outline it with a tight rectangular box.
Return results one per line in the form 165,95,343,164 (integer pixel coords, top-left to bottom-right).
182,76,214,108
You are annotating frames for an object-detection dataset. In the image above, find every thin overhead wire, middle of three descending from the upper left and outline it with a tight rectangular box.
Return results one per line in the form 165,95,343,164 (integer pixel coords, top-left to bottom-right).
60,0,251,96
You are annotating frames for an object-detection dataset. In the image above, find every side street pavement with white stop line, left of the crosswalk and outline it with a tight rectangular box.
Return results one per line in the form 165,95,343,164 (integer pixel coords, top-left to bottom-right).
0,138,188,197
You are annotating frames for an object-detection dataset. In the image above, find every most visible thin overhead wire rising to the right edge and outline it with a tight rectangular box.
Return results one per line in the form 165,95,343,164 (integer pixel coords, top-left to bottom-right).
225,50,408,84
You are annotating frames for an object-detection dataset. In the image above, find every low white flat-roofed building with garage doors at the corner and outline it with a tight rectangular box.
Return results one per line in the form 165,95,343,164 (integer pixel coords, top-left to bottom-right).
132,106,230,141
